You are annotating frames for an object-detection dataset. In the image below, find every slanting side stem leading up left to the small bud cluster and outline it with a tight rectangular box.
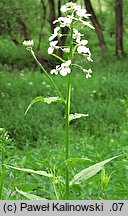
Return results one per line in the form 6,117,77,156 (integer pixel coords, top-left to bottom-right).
30,49,65,102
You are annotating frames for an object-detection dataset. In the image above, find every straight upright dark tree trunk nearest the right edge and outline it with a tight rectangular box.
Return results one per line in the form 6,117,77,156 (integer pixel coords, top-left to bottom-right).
115,0,123,58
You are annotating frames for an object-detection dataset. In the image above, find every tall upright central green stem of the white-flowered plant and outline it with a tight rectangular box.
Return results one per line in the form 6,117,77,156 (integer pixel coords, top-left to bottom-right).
65,25,73,200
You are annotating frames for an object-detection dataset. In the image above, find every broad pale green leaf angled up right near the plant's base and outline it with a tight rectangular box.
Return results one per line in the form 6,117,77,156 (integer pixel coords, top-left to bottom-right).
70,155,120,186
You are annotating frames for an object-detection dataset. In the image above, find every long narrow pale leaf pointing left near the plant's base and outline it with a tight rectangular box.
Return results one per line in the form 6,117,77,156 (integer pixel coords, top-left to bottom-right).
6,165,53,178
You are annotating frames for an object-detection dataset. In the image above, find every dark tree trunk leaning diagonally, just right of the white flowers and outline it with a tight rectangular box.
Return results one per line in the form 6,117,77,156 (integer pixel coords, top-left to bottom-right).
84,0,106,48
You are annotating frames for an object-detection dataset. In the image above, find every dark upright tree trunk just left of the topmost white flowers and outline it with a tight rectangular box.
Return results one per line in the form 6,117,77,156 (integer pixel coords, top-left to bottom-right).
49,0,56,33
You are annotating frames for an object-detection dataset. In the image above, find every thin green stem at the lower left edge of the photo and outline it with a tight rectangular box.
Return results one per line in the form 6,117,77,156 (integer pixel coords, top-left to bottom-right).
0,145,5,200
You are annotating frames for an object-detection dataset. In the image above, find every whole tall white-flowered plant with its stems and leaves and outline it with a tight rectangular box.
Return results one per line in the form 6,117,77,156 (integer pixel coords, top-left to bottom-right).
8,2,119,200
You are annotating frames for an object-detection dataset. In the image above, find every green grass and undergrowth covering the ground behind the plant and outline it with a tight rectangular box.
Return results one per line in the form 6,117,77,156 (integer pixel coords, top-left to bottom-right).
0,58,128,199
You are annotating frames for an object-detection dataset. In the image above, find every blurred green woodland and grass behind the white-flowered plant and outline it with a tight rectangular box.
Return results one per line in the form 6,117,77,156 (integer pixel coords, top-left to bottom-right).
0,0,128,199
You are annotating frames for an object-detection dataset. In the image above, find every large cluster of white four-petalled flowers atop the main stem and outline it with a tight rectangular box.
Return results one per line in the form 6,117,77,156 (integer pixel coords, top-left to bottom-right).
48,2,94,78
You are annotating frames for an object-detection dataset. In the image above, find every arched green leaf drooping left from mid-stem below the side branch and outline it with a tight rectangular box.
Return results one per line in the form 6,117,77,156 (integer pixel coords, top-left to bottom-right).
25,96,64,115
